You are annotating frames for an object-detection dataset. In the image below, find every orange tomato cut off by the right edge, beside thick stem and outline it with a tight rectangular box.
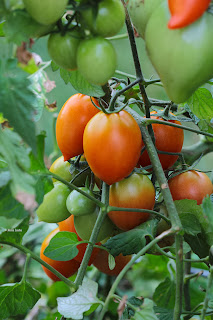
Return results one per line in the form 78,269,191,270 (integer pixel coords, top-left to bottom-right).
169,170,213,205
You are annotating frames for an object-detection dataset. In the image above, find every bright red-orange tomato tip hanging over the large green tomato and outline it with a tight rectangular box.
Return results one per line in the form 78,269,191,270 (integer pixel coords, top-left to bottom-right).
168,0,211,29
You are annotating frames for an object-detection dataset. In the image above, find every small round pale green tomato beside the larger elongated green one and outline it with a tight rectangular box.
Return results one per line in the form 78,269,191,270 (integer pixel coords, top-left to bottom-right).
66,187,96,216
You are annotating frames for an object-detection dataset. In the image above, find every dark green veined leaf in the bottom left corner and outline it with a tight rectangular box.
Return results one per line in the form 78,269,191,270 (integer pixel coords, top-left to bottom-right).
0,282,41,319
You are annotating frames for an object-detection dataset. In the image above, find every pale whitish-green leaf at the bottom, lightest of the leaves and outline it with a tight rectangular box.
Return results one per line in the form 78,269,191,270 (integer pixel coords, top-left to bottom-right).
57,278,101,320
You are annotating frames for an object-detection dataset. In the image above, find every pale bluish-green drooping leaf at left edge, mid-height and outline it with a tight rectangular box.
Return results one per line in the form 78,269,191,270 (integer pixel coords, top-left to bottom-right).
0,129,35,197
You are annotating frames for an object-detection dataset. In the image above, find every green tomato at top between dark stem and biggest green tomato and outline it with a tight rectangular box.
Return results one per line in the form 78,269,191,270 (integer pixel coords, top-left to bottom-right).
128,0,162,38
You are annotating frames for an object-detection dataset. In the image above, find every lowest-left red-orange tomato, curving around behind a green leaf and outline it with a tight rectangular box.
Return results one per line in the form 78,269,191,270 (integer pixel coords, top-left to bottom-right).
40,228,80,281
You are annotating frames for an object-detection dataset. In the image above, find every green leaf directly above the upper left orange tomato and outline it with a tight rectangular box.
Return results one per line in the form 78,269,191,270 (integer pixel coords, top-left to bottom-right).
51,63,105,98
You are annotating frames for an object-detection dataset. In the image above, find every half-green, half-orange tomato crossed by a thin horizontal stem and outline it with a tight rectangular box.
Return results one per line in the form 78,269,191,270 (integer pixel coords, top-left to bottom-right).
108,173,155,230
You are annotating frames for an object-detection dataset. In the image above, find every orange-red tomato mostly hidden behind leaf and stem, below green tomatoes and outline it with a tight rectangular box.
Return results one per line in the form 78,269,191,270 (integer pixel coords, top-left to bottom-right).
58,215,101,266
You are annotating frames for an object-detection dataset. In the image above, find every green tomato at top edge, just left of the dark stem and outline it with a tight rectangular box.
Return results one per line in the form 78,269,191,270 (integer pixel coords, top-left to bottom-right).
81,0,125,37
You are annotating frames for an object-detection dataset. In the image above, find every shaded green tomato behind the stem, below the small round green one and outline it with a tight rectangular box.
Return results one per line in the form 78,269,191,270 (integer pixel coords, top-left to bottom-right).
74,208,117,242
